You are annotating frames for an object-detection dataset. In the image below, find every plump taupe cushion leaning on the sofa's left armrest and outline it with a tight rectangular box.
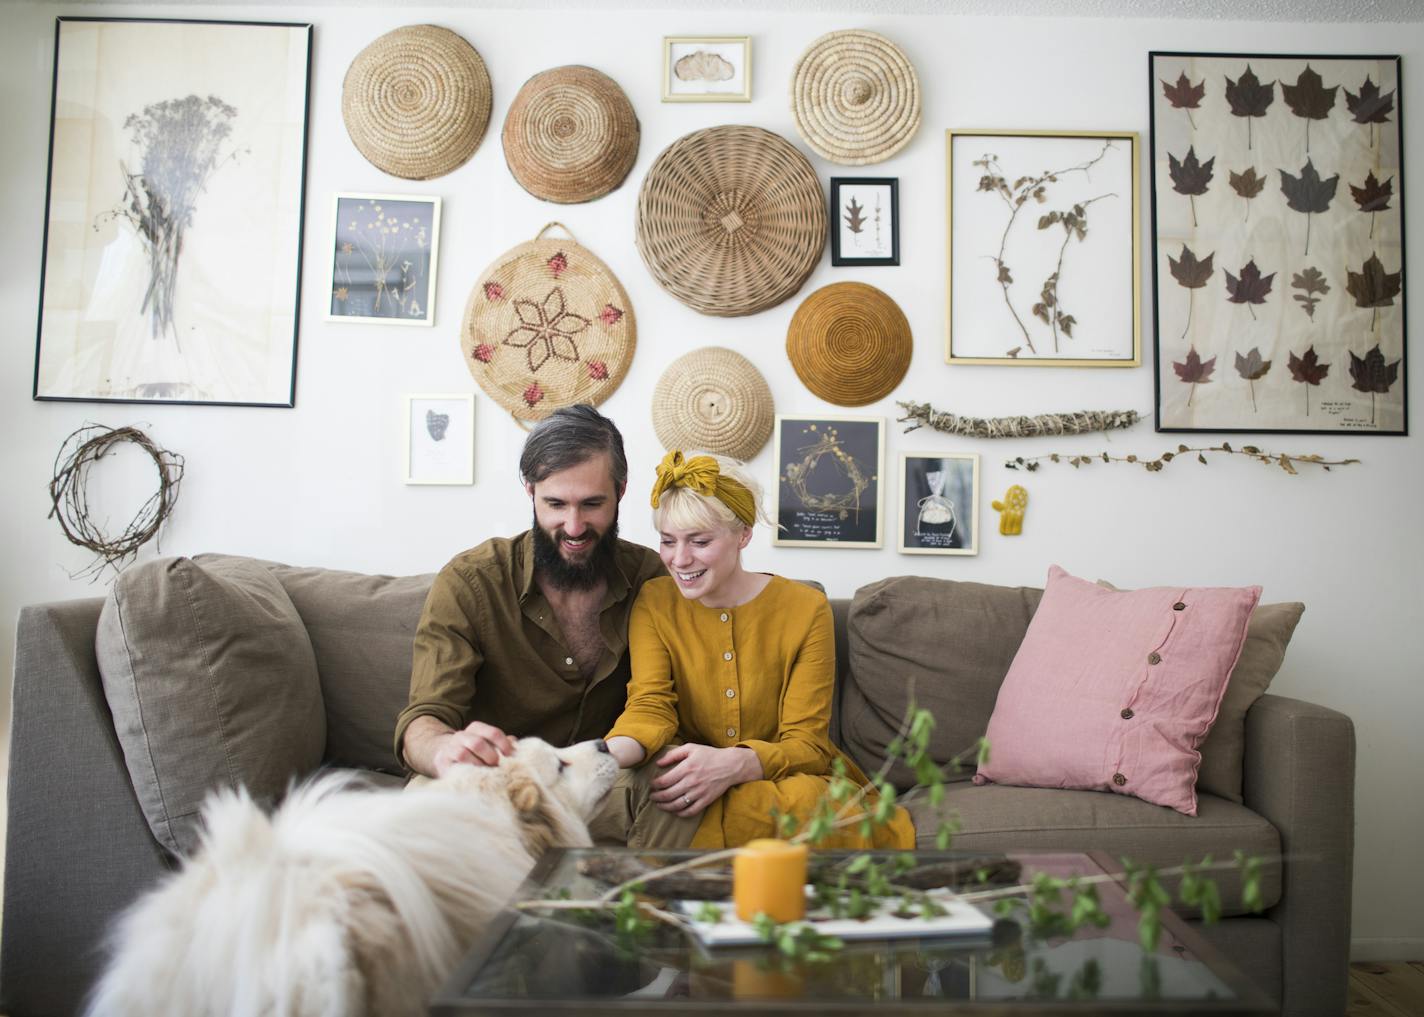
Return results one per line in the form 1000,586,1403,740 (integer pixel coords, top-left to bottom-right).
94,558,326,855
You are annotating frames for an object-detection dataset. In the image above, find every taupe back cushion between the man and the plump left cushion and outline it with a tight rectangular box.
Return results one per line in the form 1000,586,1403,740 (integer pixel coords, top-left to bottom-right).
216,556,434,773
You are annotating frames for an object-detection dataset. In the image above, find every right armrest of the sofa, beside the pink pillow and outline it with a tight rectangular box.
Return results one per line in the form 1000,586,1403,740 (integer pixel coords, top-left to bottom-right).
1243,695,1354,1014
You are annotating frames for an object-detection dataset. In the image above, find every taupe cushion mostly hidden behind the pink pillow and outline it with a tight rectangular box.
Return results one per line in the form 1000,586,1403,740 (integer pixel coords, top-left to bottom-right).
1098,580,1306,802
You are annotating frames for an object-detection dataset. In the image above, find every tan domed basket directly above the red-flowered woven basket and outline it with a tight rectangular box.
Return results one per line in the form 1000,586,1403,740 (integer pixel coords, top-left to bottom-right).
504,66,639,205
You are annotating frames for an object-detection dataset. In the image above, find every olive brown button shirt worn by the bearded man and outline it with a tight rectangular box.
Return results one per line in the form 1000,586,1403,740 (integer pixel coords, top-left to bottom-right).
396,531,665,763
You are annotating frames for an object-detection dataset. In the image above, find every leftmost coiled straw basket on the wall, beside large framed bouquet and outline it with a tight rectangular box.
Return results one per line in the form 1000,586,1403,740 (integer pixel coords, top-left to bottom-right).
342,24,491,179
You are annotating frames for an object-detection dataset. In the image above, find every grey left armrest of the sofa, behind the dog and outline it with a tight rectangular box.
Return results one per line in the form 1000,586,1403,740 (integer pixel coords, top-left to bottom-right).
0,600,169,1017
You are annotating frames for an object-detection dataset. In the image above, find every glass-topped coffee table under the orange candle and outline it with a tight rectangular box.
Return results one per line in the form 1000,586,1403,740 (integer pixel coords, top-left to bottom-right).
430,848,1276,1017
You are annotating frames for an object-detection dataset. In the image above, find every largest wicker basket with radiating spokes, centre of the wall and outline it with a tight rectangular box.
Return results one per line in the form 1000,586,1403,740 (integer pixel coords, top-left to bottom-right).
637,125,826,318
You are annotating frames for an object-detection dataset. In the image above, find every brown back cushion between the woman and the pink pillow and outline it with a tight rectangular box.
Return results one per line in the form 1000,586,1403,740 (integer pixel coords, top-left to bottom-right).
840,575,1042,789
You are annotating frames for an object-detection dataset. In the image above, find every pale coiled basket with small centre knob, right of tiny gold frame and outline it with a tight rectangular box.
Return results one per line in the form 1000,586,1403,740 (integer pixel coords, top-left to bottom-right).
792,30,920,167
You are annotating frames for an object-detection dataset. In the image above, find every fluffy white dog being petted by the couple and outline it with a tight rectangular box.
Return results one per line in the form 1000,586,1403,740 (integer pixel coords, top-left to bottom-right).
87,738,618,1017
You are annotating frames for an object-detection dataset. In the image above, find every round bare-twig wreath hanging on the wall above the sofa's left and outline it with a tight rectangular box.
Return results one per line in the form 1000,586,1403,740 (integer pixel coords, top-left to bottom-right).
50,424,184,581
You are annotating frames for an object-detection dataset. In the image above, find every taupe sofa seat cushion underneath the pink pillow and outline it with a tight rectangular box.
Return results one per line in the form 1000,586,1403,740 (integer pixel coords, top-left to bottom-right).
906,783,1280,917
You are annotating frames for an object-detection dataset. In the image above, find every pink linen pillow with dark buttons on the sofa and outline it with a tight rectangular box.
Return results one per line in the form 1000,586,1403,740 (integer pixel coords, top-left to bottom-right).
974,565,1260,816
